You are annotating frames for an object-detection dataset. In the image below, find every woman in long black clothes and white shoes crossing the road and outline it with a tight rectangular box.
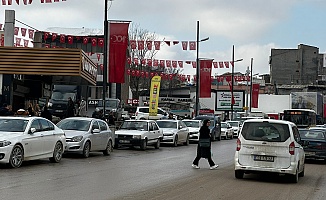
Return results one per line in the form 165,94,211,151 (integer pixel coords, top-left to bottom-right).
192,119,218,169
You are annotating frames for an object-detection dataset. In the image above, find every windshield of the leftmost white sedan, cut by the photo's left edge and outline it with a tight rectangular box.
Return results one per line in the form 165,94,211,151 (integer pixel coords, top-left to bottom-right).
0,119,28,132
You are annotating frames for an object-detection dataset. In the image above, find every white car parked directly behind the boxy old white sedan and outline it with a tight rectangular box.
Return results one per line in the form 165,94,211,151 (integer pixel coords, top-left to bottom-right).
156,119,189,147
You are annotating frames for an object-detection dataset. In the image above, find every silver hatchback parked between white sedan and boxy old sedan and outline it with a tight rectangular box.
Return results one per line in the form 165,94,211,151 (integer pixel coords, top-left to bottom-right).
57,117,115,158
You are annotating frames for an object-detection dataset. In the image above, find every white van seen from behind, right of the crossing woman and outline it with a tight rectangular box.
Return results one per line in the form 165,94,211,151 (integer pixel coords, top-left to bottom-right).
234,119,305,183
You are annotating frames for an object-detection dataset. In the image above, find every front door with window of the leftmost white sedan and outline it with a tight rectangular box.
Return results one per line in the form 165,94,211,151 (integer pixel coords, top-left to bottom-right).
22,119,44,158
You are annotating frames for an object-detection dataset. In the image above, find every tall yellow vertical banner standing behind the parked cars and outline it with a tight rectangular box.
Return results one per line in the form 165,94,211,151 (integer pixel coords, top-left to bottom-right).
149,76,161,116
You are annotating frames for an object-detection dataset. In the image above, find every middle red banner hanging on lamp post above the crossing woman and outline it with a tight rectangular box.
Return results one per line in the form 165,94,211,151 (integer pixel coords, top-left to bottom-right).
199,60,213,98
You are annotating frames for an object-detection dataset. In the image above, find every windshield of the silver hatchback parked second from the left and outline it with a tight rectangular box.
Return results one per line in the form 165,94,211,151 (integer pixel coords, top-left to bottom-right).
57,119,91,131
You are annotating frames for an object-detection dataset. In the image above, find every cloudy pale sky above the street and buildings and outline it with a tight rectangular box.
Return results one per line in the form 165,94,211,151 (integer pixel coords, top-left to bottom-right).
0,0,326,75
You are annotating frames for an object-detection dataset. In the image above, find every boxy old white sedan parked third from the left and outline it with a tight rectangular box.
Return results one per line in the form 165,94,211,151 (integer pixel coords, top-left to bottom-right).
115,120,163,150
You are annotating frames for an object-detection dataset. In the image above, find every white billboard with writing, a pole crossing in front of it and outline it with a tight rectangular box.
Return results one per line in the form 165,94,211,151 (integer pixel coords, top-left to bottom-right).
215,91,245,111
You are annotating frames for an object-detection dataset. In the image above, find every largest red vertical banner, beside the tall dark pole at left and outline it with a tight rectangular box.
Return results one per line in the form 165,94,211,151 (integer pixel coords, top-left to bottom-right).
108,23,129,83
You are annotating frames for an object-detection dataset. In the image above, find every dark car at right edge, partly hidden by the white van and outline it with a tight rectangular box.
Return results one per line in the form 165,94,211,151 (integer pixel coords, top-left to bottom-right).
299,127,326,160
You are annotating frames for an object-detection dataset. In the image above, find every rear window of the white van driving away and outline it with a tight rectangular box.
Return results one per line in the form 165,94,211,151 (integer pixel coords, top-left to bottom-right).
241,122,290,142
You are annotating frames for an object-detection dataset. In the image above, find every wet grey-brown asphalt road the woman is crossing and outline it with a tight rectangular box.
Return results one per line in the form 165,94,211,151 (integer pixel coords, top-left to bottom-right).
0,140,326,200
